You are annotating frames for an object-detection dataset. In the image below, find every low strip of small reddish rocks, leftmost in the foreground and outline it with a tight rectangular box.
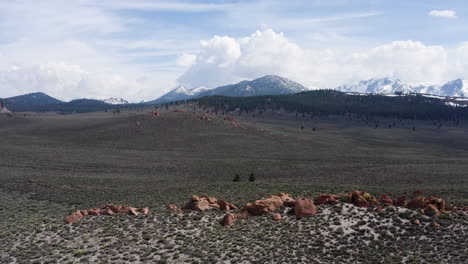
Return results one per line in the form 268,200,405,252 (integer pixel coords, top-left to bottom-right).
63,204,149,224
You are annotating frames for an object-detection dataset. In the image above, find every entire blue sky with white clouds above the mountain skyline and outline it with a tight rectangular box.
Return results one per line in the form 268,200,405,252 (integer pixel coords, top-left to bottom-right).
0,0,468,102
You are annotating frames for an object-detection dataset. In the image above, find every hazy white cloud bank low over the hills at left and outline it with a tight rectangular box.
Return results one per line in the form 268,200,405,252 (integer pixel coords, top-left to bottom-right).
0,62,168,101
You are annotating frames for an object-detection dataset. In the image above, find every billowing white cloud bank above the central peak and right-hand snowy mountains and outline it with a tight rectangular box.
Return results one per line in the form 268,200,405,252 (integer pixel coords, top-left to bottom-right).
179,29,468,88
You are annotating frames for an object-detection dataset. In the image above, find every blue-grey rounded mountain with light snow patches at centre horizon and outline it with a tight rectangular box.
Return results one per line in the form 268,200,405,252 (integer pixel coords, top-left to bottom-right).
147,75,308,103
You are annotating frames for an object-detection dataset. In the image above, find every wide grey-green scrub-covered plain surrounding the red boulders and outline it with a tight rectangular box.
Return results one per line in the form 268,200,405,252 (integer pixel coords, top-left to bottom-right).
0,106,468,263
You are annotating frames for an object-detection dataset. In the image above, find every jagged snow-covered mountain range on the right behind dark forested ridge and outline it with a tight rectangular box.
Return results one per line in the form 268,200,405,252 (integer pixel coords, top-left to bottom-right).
336,78,468,97
